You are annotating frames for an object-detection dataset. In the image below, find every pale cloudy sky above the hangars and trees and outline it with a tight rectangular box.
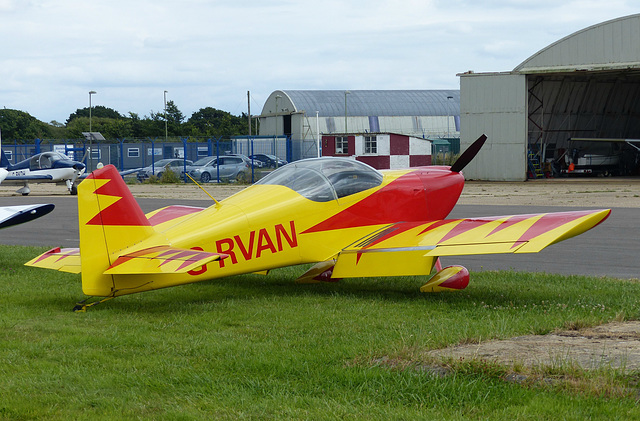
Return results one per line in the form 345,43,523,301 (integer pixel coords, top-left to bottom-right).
0,0,640,122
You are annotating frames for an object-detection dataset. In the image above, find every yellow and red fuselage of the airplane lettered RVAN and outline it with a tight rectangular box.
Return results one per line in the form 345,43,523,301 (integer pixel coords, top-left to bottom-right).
96,167,464,295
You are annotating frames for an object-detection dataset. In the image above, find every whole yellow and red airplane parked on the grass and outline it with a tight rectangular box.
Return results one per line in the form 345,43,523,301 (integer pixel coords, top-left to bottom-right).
26,135,610,310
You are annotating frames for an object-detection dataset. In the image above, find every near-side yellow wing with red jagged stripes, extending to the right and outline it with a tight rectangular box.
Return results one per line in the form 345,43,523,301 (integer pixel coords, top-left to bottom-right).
333,209,611,278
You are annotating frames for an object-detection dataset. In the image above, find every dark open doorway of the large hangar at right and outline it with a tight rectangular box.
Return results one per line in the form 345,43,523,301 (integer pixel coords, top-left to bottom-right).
527,70,640,178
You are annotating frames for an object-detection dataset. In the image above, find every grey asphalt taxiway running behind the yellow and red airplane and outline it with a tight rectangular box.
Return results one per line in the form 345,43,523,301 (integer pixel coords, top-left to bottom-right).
0,195,640,279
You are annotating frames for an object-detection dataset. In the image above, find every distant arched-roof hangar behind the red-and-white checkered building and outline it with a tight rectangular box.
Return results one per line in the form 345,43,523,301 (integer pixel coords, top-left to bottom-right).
257,89,460,159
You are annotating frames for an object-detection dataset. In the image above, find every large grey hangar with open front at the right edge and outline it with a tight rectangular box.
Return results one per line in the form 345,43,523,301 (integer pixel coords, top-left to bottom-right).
459,14,640,181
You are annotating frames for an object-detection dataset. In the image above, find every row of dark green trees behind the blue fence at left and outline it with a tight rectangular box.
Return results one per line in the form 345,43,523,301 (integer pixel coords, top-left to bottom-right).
0,101,249,142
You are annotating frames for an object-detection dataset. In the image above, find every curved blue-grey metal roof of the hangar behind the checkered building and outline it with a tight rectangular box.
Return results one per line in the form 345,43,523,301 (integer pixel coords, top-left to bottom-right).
263,89,460,117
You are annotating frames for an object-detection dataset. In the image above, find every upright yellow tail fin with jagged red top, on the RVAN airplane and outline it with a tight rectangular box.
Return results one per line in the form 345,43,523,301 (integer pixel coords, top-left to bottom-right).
78,165,155,297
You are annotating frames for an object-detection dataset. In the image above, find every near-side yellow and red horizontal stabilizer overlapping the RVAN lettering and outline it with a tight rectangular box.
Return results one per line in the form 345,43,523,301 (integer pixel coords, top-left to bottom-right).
104,246,228,275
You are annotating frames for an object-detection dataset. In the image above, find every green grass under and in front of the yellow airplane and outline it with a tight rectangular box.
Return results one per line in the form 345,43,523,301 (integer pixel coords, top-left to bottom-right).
0,246,640,420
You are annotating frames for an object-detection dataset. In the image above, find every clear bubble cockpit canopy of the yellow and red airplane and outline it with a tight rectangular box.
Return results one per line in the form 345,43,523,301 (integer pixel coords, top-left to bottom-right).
256,158,382,202
